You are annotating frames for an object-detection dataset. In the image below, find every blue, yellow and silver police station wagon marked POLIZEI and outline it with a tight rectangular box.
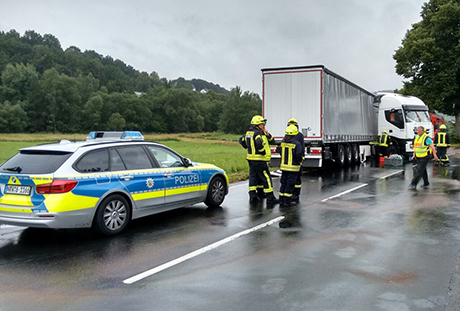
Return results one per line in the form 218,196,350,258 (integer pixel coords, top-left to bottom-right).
0,132,229,235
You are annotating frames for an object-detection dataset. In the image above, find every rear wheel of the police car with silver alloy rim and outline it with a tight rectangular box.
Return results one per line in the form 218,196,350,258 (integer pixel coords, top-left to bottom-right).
93,194,131,236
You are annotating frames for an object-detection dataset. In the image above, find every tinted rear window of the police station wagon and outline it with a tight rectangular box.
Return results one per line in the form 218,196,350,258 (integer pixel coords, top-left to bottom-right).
0,150,72,174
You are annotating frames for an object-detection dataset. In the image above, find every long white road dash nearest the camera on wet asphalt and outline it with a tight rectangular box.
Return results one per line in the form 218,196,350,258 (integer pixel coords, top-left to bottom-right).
123,216,284,284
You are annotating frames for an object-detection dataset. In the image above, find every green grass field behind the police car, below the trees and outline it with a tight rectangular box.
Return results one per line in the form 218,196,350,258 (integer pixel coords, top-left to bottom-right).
0,133,249,182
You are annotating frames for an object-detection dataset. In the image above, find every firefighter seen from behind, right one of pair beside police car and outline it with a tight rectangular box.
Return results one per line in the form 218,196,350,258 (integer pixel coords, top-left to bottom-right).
278,124,303,205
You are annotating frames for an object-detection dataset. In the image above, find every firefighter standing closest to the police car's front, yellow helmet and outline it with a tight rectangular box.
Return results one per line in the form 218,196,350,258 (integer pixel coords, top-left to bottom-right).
239,115,279,204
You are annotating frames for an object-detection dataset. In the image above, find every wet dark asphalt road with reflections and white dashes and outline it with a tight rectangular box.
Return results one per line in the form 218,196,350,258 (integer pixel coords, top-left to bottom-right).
0,151,460,311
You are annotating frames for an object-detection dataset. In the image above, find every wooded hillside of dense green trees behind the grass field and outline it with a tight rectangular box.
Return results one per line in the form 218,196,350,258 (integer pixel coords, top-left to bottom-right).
0,30,262,133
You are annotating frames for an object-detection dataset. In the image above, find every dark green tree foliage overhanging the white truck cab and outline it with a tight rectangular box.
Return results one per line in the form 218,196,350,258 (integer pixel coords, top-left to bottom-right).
393,0,460,134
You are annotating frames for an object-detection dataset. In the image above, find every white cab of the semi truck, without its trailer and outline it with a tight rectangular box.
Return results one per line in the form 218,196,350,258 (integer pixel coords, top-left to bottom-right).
377,92,434,154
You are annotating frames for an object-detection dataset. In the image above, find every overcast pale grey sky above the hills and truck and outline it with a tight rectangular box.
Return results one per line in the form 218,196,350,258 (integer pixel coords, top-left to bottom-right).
0,0,426,94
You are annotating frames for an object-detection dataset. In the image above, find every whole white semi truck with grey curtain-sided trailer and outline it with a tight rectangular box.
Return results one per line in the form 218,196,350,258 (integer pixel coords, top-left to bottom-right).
261,65,433,167
